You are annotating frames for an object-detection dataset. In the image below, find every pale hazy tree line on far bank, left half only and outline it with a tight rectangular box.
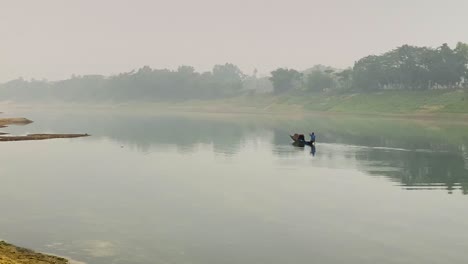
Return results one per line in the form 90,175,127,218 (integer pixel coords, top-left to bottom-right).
0,63,270,101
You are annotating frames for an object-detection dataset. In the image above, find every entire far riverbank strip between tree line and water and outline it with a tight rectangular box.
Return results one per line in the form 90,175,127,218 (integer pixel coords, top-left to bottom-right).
0,90,468,121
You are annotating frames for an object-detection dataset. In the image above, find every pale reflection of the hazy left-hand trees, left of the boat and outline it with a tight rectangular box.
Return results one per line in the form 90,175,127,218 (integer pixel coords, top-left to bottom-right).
38,114,265,154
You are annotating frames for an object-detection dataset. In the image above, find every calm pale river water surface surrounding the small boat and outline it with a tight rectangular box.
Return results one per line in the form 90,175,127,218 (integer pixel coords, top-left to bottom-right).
0,111,468,264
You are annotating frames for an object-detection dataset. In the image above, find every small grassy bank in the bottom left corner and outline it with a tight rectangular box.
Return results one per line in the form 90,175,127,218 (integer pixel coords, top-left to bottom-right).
0,241,69,264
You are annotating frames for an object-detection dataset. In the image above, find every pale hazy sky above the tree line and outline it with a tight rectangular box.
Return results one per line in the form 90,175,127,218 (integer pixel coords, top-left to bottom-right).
0,0,468,82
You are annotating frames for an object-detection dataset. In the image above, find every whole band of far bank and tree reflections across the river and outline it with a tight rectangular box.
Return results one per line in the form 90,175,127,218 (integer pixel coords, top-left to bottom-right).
9,109,468,194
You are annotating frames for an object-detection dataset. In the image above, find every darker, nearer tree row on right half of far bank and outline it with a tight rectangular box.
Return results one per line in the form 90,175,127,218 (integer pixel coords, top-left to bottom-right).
270,42,468,93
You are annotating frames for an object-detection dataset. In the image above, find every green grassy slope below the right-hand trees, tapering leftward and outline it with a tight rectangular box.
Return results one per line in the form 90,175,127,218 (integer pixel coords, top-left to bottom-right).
161,90,468,115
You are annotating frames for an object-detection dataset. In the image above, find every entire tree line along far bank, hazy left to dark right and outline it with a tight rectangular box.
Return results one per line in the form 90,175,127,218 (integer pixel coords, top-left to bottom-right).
0,43,468,101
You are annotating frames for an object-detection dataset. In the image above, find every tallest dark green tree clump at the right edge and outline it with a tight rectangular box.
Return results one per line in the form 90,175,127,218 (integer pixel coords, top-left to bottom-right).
352,43,468,90
